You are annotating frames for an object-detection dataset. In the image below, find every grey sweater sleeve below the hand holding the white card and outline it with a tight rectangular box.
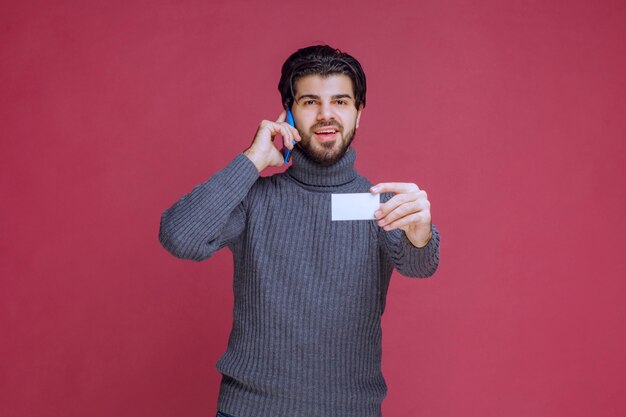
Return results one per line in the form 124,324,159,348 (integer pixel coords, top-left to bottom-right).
380,224,439,278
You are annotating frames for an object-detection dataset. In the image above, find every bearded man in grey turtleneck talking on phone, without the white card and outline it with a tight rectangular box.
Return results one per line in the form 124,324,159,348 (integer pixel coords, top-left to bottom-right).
159,45,439,417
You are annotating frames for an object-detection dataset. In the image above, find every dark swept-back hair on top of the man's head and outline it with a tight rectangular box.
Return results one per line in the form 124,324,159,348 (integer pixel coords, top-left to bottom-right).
278,45,366,109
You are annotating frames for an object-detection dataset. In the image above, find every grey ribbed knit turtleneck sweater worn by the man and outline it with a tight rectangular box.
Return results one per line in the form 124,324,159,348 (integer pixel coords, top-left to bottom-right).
159,149,439,417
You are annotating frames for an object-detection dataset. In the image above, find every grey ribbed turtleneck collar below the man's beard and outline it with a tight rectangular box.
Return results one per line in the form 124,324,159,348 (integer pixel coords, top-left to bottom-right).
285,147,358,187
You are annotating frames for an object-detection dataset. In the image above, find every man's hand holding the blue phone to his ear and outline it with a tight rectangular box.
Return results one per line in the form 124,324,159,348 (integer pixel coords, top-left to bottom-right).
243,110,301,172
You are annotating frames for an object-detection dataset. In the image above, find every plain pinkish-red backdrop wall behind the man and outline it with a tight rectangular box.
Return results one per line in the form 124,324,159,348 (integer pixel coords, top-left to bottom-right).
0,0,626,417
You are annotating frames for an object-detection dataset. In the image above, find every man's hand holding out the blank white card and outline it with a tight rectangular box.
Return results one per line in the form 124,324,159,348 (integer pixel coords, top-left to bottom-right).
370,182,432,248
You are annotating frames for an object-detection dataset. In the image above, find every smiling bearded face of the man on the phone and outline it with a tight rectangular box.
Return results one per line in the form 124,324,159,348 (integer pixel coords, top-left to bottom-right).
291,74,362,166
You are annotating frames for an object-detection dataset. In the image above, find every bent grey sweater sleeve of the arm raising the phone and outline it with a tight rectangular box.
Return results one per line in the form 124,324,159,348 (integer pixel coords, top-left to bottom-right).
159,154,259,261
